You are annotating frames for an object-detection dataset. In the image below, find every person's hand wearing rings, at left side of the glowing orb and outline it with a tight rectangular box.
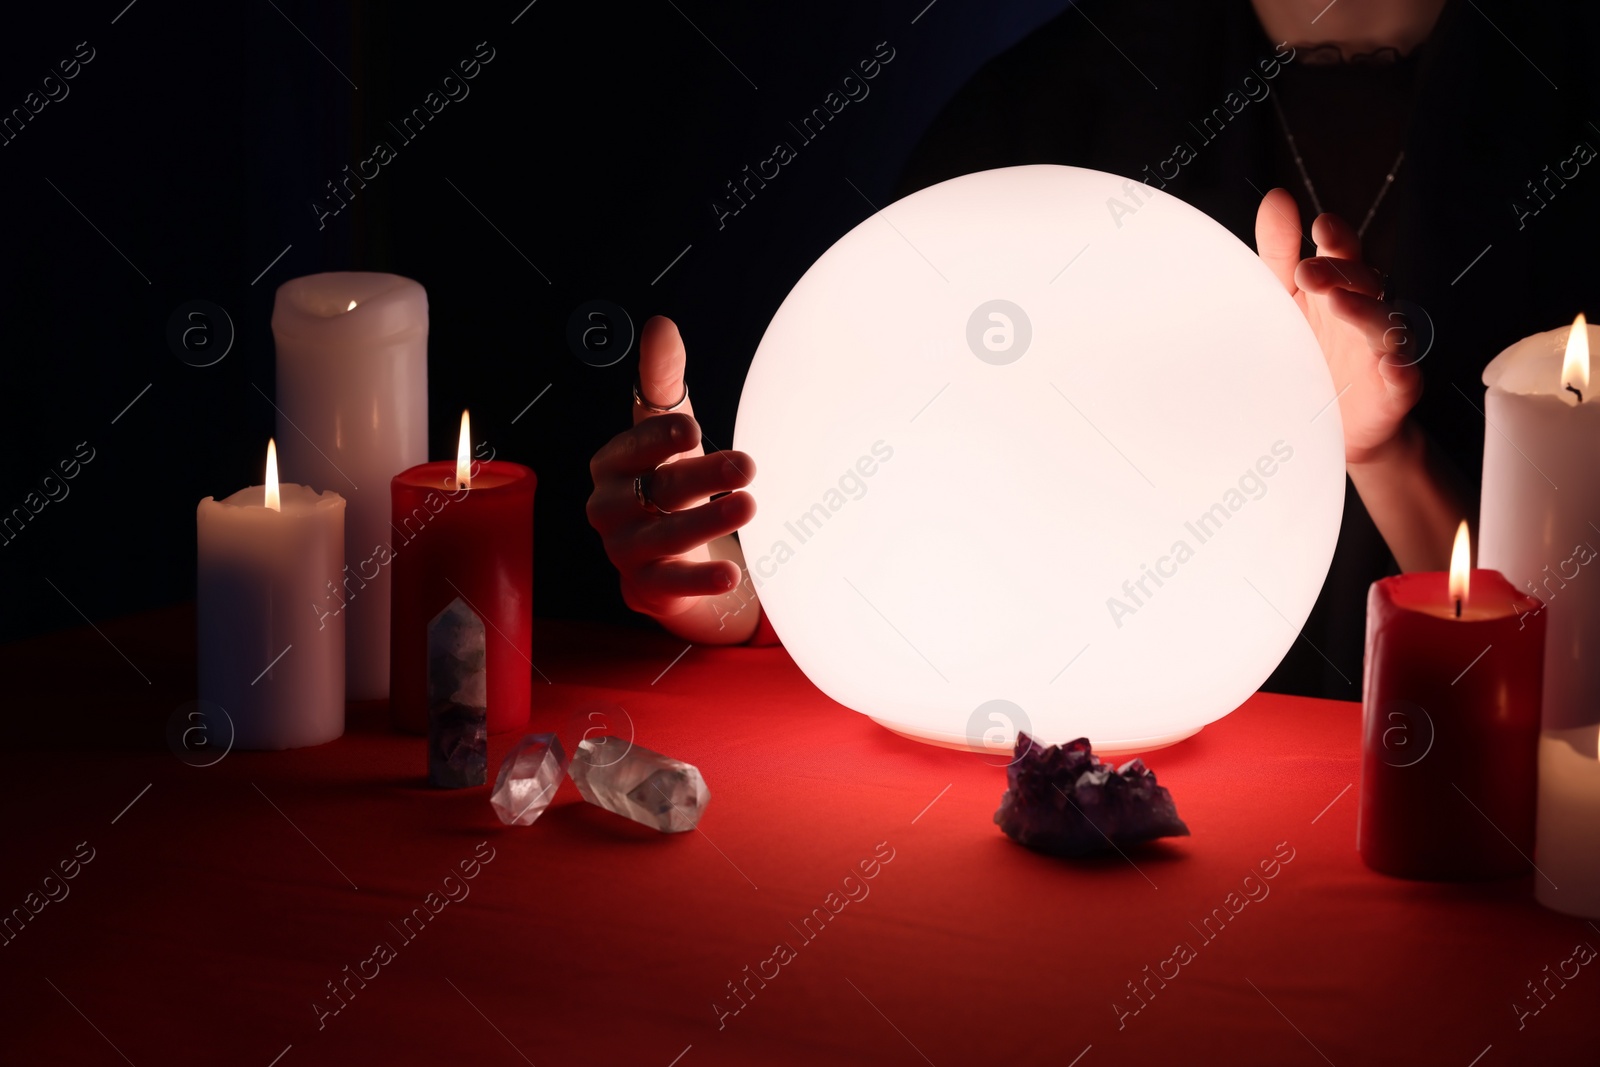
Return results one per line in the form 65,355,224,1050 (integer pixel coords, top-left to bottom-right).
586,315,755,620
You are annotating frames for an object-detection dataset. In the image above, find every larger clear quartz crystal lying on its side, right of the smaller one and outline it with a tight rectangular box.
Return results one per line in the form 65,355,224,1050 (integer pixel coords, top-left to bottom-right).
571,737,710,833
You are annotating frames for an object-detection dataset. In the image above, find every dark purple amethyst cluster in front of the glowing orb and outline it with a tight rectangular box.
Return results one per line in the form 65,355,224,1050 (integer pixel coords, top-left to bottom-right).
995,731,1189,856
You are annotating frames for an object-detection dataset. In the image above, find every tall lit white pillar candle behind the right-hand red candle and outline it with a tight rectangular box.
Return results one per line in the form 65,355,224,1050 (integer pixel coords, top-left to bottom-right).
1478,317,1600,731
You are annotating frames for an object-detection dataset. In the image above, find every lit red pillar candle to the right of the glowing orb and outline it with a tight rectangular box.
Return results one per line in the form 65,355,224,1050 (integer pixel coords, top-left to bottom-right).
1357,523,1544,881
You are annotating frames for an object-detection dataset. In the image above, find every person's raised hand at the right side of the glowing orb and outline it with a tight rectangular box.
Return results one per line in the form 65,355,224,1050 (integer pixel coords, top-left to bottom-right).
1256,189,1422,464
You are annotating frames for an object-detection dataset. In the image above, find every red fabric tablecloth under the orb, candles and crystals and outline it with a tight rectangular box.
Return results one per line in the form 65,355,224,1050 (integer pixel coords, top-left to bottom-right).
0,611,1600,1067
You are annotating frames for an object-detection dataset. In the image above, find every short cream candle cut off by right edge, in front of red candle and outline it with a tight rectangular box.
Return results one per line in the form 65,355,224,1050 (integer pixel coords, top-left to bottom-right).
1533,726,1600,918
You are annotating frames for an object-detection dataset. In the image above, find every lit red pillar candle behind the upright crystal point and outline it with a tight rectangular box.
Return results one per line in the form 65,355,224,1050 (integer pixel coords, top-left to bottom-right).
389,413,538,734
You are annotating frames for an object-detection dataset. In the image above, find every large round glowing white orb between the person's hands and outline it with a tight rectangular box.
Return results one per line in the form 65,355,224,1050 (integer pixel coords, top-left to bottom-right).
734,166,1344,752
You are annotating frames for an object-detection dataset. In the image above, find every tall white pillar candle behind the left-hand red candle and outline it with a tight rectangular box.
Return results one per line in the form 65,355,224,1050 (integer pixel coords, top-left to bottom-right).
272,272,427,701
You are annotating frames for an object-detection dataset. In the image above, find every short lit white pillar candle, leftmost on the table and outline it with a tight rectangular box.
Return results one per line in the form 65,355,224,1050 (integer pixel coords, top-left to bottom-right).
195,443,344,749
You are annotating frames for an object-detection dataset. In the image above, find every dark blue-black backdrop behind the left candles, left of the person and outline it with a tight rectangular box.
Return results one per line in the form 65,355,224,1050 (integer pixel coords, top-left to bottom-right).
0,0,1066,640
